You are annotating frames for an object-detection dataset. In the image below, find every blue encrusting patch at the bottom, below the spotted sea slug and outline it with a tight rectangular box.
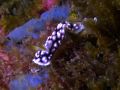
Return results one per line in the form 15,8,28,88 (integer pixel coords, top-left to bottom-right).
9,71,49,90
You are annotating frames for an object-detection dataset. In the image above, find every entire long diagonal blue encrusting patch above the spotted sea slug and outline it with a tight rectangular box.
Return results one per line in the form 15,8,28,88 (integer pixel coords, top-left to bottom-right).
7,2,70,45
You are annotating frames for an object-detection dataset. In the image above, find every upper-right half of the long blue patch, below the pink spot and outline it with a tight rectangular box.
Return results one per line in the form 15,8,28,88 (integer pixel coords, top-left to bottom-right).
40,5,70,22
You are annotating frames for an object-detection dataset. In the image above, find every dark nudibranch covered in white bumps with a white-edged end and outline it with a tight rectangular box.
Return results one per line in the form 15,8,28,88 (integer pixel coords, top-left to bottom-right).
33,21,85,66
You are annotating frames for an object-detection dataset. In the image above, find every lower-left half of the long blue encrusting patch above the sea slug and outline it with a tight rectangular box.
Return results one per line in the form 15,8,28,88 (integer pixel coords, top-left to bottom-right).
7,19,44,42
